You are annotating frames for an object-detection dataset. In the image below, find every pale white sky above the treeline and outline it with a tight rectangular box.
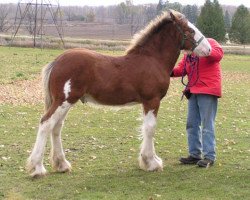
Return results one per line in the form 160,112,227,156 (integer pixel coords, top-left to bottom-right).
0,0,250,7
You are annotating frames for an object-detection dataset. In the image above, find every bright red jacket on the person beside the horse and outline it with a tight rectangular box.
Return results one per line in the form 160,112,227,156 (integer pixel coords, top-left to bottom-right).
172,38,224,97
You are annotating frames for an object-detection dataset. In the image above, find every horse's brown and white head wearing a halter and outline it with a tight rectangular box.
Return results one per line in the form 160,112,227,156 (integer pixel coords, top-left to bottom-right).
170,10,211,56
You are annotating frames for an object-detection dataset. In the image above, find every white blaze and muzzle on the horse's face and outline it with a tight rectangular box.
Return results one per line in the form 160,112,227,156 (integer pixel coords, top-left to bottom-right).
188,22,211,56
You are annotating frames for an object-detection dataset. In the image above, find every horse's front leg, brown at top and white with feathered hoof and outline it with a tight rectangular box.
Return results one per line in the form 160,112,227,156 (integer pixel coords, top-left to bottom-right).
139,99,163,171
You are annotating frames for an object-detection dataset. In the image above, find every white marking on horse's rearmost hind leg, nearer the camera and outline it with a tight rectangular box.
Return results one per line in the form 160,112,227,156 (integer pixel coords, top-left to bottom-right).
27,101,71,177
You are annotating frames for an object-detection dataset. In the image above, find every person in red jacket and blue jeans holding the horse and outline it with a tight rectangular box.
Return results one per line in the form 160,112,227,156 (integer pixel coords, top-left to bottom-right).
171,38,224,167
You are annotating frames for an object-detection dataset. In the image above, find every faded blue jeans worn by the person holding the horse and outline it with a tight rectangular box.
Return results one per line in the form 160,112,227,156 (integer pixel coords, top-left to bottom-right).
186,94,218,160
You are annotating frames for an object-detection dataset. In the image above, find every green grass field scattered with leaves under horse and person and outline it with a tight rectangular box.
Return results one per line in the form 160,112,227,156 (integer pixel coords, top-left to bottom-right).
0,47,250,200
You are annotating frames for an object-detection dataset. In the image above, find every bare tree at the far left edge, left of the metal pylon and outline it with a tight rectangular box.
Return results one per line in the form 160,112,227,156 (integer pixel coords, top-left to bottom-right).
0,4,11,32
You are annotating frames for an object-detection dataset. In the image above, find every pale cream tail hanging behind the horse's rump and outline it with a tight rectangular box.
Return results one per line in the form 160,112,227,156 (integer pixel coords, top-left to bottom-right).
42,62,54,111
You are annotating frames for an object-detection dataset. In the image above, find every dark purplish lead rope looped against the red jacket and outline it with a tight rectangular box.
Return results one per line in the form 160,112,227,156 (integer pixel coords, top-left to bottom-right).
181,55,200,100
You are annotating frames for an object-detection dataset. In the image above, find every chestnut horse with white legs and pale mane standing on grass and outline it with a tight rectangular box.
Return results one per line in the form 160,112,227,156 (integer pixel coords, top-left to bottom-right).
27,10,211,177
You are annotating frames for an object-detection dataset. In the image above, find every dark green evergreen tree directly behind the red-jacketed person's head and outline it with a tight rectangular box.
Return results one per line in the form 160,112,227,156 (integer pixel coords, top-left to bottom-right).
197,0,226,41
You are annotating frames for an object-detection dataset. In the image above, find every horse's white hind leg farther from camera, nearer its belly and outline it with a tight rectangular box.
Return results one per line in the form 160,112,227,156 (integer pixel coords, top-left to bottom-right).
51,103,71,172
